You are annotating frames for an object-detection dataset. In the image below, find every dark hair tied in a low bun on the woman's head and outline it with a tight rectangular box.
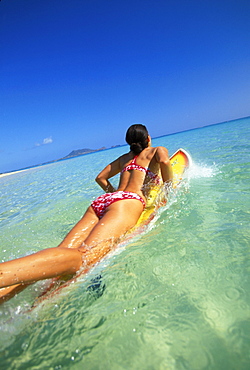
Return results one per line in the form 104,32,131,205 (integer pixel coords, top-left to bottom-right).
126,124,148,154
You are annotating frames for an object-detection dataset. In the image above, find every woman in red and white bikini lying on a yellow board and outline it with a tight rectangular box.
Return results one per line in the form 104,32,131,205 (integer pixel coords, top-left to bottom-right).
0,124,172,301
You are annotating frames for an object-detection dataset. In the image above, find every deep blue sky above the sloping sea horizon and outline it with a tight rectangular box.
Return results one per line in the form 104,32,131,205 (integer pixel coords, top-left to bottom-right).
0,0,250,172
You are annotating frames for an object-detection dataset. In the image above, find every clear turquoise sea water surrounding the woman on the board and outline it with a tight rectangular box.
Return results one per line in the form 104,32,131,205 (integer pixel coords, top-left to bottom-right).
0,118,250,370
